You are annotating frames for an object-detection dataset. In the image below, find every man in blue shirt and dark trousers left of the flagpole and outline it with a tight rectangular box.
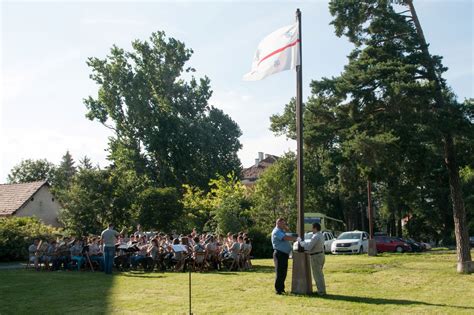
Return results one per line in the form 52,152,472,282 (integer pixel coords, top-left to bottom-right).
272,218,297,294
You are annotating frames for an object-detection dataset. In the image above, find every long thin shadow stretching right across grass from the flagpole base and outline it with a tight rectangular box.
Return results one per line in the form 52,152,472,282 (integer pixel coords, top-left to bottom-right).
304,294,474,310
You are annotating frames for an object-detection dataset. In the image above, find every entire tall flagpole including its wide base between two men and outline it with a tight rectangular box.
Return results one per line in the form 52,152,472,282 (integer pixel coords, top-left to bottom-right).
291,9,312,294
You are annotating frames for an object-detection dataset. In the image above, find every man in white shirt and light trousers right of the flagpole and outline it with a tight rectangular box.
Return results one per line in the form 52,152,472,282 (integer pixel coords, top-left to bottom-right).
300,222,326,295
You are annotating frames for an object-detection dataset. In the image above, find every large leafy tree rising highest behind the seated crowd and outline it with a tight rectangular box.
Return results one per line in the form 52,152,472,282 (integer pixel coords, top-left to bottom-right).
84,32,241,189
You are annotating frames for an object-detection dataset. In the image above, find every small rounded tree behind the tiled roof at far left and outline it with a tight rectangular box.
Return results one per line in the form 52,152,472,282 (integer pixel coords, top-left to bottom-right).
7,159,56,184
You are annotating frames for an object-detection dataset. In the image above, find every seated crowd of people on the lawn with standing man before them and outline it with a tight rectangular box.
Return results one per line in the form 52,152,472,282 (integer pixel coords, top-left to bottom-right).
28,226,252,273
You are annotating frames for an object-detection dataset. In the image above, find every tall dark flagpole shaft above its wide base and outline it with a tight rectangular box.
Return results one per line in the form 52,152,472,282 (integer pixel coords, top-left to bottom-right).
296,9,304,239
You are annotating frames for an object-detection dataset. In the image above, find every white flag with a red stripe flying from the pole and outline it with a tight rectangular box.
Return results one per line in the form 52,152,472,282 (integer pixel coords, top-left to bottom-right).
244,23,300,81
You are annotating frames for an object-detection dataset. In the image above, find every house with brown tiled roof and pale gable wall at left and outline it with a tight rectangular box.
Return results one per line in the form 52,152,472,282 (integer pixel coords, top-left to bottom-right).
0,181,62,226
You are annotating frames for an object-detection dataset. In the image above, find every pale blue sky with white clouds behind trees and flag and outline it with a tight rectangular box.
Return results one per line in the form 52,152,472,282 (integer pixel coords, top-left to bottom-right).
0,0,474,182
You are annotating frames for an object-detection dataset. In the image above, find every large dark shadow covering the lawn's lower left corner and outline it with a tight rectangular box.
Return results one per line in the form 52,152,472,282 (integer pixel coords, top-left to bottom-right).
0,269,115,314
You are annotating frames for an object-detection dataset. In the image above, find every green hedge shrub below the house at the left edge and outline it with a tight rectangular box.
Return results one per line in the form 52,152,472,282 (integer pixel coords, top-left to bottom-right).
0,217,61,261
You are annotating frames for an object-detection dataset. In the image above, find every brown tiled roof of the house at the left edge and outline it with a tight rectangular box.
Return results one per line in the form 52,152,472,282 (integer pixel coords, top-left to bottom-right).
0,181,47,216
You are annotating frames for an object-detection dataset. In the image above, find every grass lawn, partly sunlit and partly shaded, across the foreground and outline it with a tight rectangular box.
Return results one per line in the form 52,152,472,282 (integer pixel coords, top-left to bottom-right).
0,251,474,314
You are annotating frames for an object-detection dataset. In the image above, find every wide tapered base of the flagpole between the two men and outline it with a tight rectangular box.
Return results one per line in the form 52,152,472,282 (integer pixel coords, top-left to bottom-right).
291,251,313,294
